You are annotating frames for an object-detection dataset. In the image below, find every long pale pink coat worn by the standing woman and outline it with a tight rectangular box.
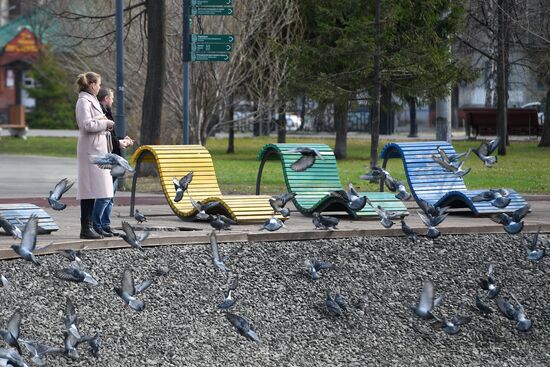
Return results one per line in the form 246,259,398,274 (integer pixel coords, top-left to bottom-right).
76,92,113,200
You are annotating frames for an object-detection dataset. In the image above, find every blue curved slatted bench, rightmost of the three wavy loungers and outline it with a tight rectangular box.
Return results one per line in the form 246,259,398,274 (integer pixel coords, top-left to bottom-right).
380,141,527,215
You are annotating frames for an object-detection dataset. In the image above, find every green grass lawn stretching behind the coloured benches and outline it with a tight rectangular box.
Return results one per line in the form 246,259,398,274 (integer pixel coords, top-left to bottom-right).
0,137,550,194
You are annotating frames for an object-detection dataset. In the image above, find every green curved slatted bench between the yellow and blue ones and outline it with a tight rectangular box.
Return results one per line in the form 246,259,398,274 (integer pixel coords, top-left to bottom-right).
256,144,407,218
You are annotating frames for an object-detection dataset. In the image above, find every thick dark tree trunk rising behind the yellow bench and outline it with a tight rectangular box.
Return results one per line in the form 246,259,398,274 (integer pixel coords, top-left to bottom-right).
139,0,166,145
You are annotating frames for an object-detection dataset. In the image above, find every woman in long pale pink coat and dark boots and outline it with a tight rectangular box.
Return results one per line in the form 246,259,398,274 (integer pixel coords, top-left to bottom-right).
76,72,115,239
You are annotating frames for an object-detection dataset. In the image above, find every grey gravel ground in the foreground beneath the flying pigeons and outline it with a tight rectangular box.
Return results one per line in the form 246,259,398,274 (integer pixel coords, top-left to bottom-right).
0,235,550,366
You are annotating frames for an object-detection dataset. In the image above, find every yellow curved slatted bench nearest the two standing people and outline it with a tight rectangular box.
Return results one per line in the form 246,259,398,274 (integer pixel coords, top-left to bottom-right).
130,145,280,223
